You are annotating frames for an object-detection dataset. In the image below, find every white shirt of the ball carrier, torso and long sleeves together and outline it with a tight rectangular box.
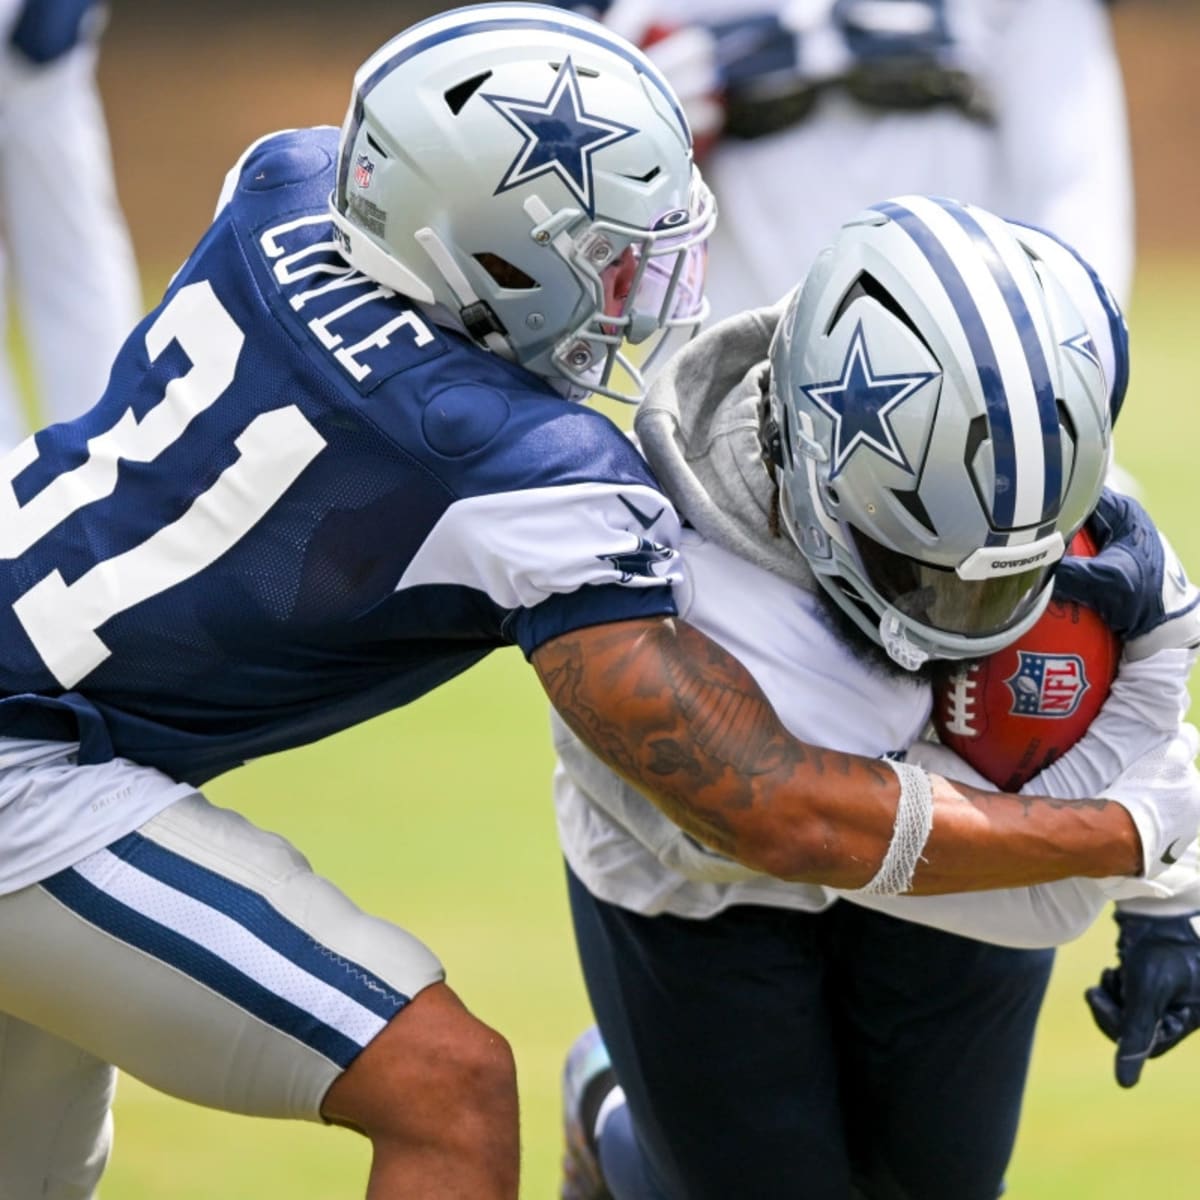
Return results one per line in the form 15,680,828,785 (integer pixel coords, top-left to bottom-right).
552,529,1200,947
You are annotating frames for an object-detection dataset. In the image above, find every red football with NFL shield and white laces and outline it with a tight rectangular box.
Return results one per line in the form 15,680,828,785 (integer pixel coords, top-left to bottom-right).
934,532,1121,792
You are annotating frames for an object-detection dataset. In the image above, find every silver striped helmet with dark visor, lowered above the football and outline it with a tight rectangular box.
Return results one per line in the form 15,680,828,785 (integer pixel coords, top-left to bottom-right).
770,196,1128,670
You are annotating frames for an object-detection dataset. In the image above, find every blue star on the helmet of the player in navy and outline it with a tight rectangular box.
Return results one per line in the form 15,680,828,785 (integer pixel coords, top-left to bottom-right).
482,58,637,217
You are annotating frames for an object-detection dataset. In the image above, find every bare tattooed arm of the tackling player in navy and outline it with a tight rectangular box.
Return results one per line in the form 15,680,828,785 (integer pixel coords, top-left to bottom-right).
532,618,1142,894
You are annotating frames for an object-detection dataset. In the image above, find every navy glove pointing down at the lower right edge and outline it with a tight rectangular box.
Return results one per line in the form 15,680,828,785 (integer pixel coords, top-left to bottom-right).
1084,912,1200,1087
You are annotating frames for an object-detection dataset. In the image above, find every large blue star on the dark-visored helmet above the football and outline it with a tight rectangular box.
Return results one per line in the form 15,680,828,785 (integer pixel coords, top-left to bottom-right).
800,322,937,479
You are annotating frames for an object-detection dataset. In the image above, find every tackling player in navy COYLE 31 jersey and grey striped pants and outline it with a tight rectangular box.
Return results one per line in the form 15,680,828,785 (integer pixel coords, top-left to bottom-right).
0,4,1200,1200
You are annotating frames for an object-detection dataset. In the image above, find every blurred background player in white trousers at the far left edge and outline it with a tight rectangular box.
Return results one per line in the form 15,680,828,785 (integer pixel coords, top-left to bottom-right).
0,0,143,454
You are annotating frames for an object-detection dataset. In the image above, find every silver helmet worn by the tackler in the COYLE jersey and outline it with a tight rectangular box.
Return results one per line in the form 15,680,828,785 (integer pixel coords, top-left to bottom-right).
330,4,715,400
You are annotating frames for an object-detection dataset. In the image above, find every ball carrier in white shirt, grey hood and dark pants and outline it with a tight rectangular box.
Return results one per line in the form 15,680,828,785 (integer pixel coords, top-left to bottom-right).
554,197,1200,1200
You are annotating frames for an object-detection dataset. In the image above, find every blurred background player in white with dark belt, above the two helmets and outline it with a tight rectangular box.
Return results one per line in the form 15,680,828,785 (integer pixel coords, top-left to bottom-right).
552,0,1134,318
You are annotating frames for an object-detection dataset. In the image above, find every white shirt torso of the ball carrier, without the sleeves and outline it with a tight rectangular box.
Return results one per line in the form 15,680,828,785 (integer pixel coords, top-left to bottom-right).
554,529,931,917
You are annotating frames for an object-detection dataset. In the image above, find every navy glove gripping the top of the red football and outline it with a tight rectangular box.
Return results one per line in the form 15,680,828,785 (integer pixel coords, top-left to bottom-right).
1054,487,1200,659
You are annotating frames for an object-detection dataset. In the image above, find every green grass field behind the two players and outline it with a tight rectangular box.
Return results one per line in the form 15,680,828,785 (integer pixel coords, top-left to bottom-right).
88,263,1200,1200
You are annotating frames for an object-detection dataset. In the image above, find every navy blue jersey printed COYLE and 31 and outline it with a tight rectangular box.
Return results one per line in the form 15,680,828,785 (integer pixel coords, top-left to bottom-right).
0,128,678,782
